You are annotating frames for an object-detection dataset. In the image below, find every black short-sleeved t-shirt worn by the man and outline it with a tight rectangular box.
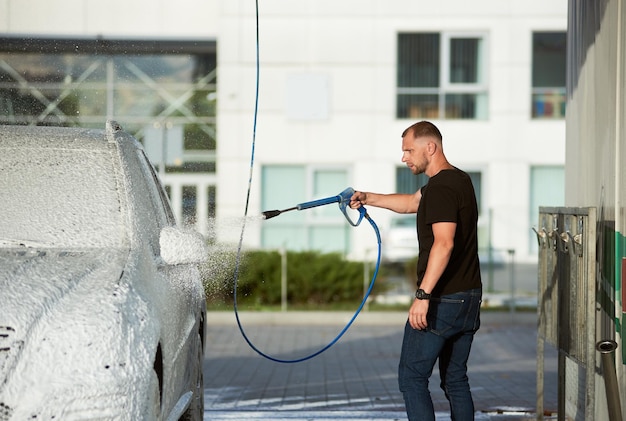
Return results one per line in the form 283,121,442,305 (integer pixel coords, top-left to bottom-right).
417,168,482,296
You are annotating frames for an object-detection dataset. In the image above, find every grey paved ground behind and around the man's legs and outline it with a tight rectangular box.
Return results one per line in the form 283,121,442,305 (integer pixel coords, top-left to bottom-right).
204,311,557,421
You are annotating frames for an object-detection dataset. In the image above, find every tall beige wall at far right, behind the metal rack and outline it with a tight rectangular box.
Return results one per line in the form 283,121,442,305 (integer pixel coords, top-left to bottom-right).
565,0,626,419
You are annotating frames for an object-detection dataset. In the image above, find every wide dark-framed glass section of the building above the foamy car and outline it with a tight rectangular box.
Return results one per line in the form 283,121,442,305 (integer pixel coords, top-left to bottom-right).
0,37,217,172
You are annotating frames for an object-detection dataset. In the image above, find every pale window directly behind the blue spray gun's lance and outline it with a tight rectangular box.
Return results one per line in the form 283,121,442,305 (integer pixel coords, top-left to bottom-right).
261,165,351,253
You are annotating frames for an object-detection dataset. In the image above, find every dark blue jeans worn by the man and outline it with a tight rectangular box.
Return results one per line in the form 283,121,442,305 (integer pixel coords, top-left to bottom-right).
398,288,482,421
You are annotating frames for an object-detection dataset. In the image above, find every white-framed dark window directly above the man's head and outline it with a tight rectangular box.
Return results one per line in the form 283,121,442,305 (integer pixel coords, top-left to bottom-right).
396,33,487,120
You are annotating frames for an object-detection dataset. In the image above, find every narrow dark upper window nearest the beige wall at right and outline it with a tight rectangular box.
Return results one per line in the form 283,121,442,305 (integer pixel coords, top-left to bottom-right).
531,32,567,119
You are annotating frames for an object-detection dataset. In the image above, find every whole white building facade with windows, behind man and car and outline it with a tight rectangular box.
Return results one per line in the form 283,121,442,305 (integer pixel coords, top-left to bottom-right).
0,0,567,261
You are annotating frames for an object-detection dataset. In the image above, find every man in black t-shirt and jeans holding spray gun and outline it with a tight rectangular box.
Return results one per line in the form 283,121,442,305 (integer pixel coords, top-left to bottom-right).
350,121,482,421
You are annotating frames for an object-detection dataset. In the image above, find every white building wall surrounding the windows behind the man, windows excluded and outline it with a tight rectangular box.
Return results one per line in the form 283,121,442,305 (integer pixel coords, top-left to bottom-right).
218,0,567,260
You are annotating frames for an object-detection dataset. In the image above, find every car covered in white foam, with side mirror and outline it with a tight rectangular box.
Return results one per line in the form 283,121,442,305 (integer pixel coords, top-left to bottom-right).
0,121,207,421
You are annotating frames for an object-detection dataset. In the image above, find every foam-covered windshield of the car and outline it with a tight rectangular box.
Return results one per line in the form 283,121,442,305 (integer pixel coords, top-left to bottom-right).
0,147,127,248
